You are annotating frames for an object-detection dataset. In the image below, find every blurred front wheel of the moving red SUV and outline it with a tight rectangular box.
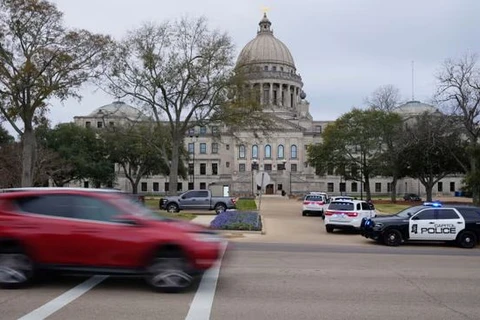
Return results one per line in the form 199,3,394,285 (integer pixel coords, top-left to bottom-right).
146,251,193,293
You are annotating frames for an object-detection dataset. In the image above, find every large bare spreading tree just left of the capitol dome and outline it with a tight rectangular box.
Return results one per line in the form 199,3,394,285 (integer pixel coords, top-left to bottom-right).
105,18,270,193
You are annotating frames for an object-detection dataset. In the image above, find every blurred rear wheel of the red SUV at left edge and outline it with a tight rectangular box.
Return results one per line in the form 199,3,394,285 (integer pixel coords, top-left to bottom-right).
0,250,34,289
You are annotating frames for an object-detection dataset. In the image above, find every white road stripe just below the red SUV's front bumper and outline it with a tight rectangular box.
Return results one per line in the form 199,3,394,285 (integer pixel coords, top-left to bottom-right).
185,242,228,320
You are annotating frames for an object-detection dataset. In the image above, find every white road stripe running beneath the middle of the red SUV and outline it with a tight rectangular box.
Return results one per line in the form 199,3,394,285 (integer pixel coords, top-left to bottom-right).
18,276,108,320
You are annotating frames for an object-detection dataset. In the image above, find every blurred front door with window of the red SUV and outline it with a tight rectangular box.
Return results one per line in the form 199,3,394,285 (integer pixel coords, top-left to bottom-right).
69,195,142,268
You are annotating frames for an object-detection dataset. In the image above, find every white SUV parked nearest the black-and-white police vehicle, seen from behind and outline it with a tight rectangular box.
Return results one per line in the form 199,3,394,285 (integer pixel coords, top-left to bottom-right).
325,200,376,233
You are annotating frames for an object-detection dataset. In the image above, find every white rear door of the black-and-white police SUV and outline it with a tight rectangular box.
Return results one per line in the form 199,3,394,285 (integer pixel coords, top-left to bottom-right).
435,208,465,241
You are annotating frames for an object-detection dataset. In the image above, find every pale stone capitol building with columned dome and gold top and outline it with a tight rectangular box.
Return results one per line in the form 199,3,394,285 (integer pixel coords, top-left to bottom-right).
74,14,462,197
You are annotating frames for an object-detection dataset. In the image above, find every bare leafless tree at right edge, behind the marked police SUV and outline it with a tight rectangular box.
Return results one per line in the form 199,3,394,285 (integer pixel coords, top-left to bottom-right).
436,54,480,205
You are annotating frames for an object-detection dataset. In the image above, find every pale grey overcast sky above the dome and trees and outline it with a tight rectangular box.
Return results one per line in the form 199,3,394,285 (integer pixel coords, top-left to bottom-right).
8,0,480,131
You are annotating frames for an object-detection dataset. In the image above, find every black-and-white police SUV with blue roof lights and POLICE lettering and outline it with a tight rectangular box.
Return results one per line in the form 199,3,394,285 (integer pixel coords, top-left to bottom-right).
360,202,480,248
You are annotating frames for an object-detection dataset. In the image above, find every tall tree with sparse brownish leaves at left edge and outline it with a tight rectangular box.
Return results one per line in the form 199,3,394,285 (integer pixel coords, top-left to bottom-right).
0,0,110,186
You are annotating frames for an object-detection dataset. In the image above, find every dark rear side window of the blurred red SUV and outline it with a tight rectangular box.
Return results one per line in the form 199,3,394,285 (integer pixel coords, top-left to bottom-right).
15,195,74,218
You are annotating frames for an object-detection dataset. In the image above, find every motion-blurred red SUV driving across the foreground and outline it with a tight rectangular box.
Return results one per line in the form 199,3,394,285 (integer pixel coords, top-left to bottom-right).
0,188,222,292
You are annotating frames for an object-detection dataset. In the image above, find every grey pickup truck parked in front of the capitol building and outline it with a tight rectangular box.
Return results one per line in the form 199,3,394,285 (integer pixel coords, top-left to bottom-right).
159,190,236,213
